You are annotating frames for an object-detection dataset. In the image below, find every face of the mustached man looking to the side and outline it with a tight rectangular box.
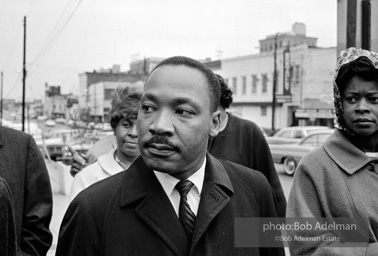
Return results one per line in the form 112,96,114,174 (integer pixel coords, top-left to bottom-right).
138,66,219,179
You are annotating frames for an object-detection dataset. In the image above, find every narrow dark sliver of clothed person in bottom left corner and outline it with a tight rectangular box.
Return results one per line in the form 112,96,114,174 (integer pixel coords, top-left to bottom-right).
0,177,17,256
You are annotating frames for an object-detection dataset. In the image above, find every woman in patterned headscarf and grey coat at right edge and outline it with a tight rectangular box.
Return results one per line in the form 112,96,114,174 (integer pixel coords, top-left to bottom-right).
287,48,378,255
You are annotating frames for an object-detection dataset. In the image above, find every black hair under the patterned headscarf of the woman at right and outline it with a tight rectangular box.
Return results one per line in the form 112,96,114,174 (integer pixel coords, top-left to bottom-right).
335,56,378,97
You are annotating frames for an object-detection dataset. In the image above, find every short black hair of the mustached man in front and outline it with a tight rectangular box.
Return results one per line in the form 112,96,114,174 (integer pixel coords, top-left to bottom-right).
146,56,220,112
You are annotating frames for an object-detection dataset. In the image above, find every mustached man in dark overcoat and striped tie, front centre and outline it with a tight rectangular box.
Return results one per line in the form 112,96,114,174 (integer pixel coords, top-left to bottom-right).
56,57,284,256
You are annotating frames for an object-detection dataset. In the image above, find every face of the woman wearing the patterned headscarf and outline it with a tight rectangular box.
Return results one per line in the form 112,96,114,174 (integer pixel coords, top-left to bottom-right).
342,76,378,136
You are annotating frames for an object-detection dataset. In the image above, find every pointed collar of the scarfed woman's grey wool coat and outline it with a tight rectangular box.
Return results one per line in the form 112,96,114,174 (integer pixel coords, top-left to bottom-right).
323,129,372,174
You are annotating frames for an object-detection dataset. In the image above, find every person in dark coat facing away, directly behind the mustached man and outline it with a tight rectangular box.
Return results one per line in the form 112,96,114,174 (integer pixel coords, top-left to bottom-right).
207,75,286,217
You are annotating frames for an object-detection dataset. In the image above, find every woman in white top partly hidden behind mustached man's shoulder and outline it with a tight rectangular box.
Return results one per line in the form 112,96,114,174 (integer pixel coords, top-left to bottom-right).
70,84,143,200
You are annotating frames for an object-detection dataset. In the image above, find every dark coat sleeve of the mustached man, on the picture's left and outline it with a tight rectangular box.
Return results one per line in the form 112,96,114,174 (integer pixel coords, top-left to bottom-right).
56,172,122,256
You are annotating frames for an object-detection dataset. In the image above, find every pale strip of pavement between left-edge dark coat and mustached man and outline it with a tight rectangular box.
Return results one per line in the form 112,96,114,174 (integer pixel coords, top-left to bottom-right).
46,160,73,256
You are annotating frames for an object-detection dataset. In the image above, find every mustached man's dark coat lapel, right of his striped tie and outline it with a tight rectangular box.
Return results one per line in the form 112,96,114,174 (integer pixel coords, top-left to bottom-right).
191,154,234,250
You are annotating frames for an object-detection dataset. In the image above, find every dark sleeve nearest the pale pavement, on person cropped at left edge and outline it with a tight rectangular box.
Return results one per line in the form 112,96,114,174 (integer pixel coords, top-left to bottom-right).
21,136,52,255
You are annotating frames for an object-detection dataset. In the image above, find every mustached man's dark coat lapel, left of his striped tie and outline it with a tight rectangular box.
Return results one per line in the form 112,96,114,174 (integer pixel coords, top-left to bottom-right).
120,157,190,255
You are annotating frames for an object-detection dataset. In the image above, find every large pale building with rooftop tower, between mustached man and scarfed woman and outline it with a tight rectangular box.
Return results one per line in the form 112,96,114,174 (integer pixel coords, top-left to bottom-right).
205,23,336,129
